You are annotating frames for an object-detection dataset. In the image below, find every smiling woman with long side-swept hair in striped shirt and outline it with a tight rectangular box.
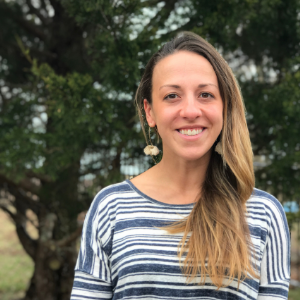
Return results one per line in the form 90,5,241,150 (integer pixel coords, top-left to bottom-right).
72,33,290,300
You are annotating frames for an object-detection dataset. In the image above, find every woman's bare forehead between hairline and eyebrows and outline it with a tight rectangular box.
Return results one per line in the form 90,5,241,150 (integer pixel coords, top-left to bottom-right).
152,51,218,88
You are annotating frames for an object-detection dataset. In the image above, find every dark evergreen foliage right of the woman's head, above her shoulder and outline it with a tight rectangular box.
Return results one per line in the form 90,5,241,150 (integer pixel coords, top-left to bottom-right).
186,0,300,200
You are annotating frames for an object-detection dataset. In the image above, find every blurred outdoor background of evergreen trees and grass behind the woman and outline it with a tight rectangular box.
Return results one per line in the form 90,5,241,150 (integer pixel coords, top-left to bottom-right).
0,0,300,300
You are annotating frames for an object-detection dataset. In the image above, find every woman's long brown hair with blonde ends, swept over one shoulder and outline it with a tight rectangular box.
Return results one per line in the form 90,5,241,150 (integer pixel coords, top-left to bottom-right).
135,32,258,289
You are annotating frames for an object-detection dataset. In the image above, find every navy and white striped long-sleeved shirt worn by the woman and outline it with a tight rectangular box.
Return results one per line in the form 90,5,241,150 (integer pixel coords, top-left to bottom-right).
71,180,290,300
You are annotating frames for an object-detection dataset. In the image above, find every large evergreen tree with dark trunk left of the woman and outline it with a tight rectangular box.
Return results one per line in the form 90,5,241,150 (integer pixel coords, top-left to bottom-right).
0,0,190,300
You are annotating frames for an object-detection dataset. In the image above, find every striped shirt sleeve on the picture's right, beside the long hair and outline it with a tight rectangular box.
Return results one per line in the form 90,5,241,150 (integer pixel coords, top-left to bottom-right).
257,198,290,300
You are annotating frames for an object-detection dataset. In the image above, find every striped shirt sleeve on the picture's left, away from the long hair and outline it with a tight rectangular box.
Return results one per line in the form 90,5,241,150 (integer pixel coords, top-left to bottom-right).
71,193,112,300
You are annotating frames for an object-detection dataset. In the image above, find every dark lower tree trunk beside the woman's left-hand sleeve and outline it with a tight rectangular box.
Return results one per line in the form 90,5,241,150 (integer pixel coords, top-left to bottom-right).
24,163,81,300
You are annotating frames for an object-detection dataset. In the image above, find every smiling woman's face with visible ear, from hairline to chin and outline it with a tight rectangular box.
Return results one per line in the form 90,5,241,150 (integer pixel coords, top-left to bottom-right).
144,51,223,160
